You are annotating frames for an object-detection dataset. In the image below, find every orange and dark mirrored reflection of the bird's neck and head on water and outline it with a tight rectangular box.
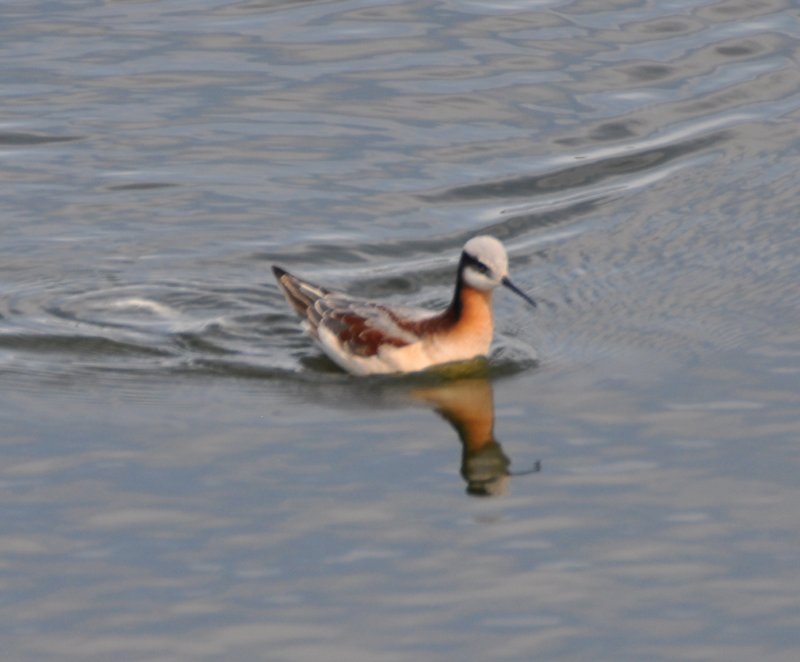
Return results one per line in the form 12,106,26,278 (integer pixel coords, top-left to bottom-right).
414,378,540,496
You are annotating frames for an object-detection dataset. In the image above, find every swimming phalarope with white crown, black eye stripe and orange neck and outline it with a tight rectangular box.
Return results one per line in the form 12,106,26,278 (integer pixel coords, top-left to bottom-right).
272,236,536,375
